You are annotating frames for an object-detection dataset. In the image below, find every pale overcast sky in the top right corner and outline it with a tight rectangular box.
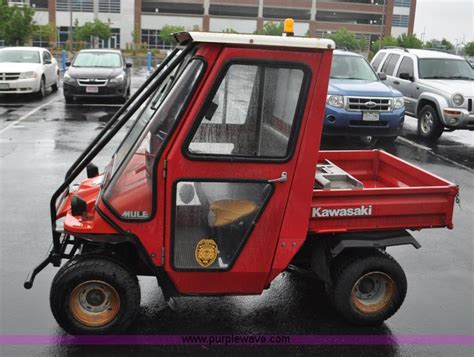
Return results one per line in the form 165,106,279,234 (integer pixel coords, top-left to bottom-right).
415,0,474,44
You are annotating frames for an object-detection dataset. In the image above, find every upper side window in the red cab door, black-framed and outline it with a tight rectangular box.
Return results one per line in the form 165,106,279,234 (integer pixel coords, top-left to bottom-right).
187,63,306,160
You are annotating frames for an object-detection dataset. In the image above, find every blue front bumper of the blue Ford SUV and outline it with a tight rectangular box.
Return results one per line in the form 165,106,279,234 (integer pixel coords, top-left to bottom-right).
323,106,405,136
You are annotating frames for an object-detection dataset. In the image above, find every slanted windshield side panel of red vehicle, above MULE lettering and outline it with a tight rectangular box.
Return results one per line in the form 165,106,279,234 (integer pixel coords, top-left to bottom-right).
104,59,204,220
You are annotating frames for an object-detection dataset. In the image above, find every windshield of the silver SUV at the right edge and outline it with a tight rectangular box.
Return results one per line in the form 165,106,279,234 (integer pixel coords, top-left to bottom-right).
418,58,474,81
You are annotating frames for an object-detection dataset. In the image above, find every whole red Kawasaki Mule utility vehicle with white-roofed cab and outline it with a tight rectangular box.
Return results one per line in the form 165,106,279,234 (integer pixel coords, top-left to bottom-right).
25,28,458,334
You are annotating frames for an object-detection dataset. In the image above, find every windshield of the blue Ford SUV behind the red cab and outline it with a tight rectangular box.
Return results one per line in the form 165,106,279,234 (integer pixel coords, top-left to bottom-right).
331,55,378,81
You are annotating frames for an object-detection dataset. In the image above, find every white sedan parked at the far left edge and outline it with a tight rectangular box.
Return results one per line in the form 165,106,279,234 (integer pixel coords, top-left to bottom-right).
0,47,59,97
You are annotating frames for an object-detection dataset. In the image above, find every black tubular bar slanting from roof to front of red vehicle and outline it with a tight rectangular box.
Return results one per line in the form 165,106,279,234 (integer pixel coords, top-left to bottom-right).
24,42,194,289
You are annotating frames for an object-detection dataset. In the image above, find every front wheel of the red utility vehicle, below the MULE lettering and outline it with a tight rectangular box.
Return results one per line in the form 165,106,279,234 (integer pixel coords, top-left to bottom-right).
50,256,140,335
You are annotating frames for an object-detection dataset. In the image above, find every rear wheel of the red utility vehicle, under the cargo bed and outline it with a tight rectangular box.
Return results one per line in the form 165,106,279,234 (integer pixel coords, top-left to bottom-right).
328,251,407,325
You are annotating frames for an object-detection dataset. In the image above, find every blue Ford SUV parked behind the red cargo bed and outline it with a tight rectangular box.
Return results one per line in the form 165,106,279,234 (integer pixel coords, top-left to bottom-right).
324,50,405,140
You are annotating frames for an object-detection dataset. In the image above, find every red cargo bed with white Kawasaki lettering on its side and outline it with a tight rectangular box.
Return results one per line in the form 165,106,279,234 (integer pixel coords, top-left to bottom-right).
309,150,458,233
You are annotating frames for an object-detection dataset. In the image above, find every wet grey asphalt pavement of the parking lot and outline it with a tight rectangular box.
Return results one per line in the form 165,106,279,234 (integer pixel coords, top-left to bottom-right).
0,70,474,356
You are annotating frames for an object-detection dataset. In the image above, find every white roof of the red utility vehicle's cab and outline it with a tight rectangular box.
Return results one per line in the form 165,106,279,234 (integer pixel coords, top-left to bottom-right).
180,32,336,50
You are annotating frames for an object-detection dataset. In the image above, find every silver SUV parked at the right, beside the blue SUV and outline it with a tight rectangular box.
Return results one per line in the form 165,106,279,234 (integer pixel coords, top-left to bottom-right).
371,48,474,140
